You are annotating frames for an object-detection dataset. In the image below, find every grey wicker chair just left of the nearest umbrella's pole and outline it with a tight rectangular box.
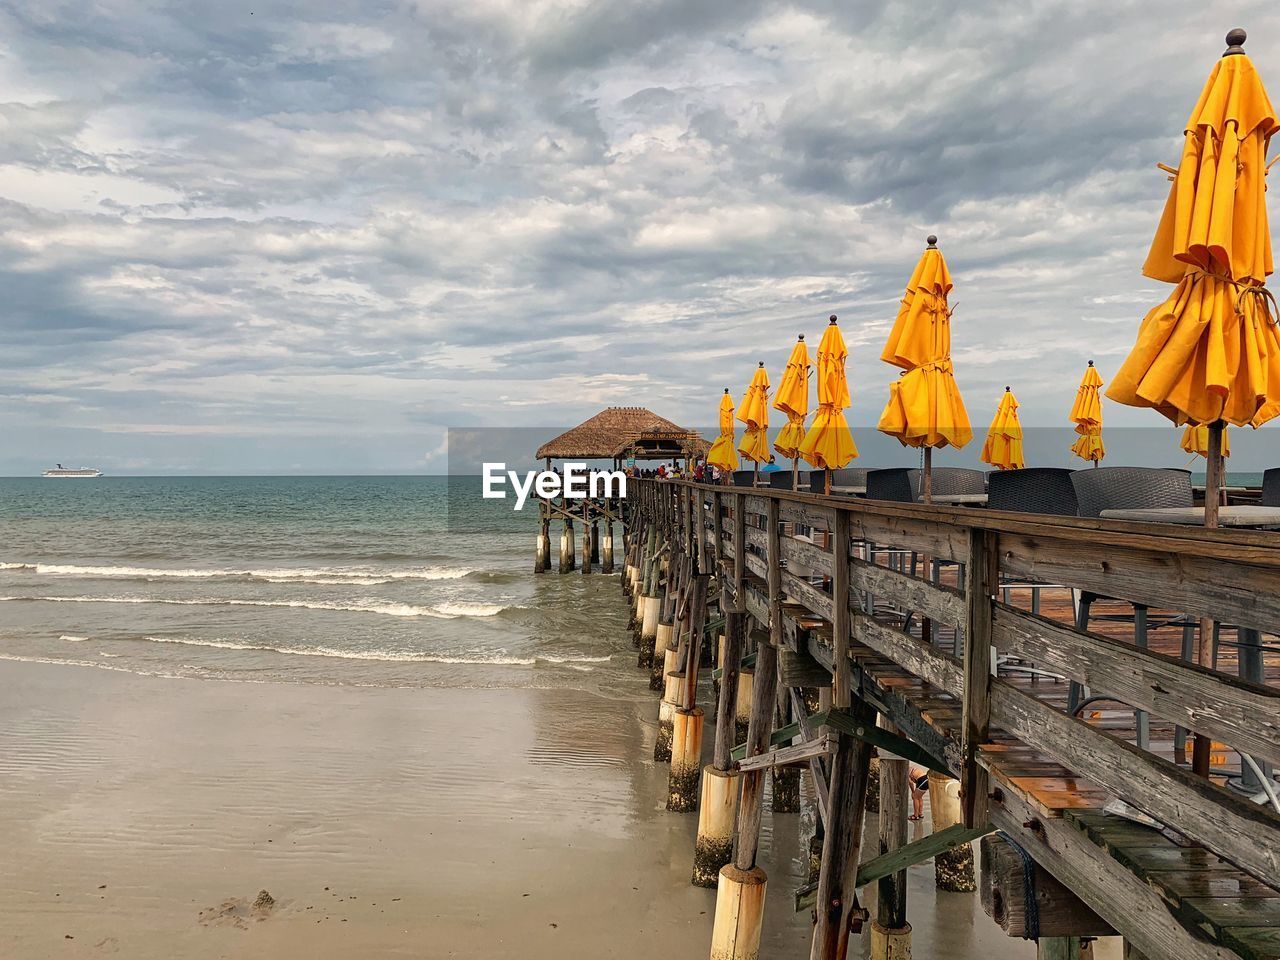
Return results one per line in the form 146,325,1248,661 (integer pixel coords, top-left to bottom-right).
1068,467,1196,750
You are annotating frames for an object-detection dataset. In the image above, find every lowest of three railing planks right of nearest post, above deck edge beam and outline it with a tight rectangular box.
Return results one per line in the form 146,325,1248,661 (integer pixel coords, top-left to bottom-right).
991,680,1280,890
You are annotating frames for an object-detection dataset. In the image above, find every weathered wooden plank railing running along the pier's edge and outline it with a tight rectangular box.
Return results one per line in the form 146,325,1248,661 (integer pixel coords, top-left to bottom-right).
628,480,1280,956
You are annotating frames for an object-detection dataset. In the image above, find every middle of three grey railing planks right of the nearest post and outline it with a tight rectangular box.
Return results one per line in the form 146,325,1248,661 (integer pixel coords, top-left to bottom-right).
992,603,1280,763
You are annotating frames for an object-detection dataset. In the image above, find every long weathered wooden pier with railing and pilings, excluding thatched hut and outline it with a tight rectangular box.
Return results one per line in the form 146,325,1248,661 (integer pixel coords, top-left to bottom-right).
622,479,1280,960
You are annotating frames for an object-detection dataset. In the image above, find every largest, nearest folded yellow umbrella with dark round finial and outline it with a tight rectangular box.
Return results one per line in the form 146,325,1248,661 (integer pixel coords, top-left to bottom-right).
1107,31,1280,430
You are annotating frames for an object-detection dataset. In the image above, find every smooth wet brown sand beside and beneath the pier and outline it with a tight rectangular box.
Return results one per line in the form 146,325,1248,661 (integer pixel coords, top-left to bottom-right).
0,662,1116,960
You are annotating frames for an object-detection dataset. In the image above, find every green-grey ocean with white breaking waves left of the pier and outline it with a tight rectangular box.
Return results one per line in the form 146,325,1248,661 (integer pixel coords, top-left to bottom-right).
0,476,636,694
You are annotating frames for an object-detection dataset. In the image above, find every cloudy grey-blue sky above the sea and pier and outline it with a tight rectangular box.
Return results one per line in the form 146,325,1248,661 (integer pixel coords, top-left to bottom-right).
0,0,1280,475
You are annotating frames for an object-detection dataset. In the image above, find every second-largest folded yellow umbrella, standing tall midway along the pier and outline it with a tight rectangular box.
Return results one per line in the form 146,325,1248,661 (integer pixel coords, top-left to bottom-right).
878,237,973,448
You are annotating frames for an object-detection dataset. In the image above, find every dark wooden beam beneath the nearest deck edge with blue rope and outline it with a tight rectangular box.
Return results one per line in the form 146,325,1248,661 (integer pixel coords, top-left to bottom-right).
979,833,1115,940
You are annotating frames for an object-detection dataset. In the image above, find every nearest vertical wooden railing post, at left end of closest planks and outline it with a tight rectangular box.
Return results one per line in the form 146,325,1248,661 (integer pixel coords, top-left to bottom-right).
960,530,1000,827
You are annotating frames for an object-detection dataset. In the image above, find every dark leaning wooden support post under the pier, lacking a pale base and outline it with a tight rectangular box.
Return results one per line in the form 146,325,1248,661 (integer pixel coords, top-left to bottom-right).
809,700,876,960
